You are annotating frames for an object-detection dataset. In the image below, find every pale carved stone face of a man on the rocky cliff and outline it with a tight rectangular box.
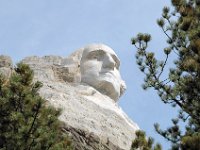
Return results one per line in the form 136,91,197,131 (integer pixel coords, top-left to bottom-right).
80,44,125,101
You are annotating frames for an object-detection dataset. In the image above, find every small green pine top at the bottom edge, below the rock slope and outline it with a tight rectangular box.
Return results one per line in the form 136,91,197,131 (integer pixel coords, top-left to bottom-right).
131,130,162,150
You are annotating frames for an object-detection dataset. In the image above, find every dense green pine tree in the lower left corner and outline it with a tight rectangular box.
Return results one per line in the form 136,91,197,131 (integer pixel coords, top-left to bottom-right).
0,63,72,150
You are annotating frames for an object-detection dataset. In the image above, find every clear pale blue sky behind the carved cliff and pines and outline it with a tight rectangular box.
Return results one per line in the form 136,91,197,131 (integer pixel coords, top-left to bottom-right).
0,0,176,149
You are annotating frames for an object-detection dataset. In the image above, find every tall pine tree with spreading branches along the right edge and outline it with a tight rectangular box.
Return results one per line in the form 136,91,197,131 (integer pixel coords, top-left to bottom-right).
132,0,200,149
